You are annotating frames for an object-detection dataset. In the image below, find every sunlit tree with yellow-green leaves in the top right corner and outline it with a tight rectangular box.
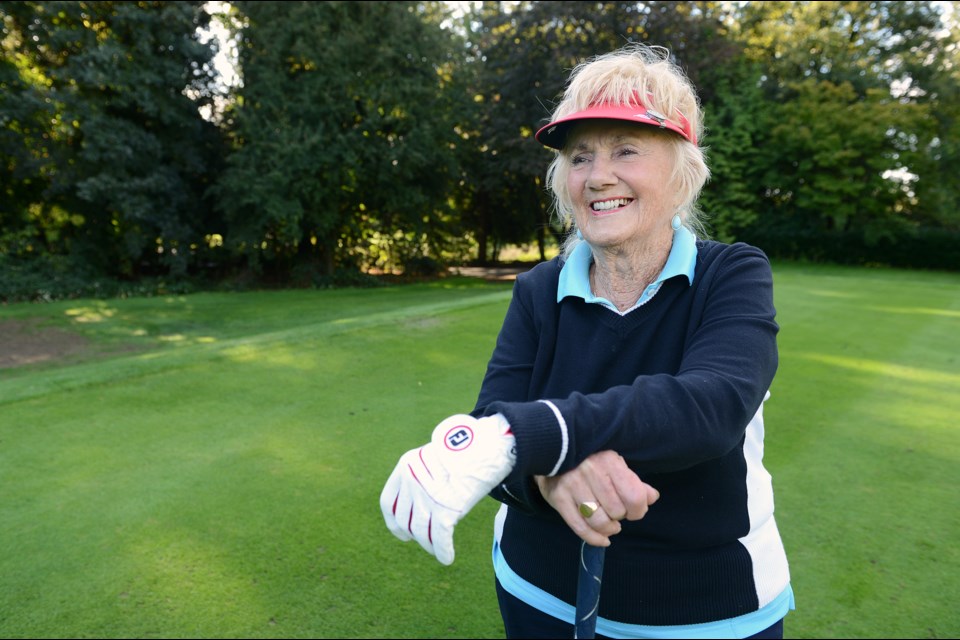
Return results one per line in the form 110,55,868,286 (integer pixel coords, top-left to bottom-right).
738,2,960,255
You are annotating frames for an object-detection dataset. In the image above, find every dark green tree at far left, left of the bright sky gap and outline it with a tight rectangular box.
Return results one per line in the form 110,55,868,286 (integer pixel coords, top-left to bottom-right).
0,2,219,276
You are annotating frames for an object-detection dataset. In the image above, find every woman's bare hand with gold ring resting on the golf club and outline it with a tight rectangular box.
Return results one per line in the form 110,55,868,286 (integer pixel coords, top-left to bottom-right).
535,451,660,547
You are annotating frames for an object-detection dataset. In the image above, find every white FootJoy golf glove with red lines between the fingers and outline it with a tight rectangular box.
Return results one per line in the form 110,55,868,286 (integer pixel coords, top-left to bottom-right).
380,414,517,565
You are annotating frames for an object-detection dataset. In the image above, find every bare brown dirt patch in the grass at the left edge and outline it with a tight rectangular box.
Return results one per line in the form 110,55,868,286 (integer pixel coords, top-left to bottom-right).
0,320,89,369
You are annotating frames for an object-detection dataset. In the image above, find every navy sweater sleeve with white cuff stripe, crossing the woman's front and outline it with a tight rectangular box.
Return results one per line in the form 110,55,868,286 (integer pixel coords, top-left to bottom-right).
482,244,779,482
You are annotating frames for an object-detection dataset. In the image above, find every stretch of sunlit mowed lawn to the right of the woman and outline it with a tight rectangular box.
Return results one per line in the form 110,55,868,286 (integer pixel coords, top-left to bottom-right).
767,266,960,638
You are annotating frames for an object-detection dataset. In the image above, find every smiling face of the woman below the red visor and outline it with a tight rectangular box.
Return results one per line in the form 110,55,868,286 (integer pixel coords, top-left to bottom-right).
564,121,680,254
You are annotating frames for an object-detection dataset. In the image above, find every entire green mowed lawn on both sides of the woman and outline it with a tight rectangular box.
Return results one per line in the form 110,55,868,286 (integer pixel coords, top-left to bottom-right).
0,264,960,638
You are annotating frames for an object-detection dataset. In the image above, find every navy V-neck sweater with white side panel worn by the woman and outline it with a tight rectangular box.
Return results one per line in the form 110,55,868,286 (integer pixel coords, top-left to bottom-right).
473,241,788,625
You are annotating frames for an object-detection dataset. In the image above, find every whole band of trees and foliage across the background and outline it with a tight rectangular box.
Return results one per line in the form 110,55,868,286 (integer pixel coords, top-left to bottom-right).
0,0,960,297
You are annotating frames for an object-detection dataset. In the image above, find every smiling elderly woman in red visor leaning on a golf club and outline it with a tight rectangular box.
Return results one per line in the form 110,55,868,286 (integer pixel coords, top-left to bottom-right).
380,45,793,638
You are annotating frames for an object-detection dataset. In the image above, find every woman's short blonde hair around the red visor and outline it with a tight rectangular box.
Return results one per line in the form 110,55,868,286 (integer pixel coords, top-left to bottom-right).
547,44,710,258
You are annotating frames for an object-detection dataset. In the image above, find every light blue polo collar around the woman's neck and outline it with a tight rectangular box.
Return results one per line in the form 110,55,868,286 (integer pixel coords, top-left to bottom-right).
557,227,697,309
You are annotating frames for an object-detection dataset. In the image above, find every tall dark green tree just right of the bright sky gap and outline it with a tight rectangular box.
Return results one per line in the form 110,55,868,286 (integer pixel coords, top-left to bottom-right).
216,2,474,274
